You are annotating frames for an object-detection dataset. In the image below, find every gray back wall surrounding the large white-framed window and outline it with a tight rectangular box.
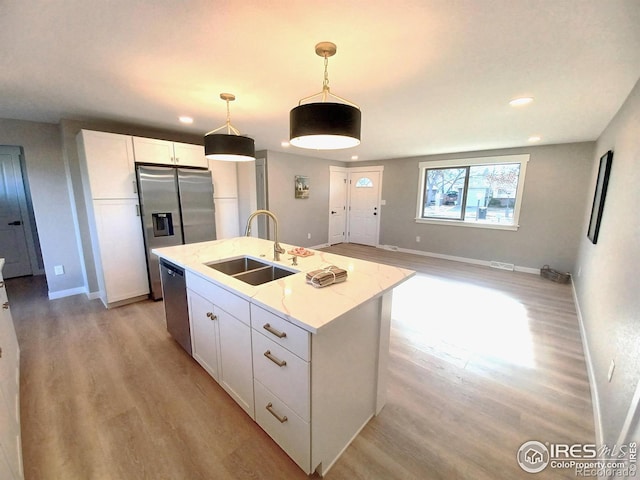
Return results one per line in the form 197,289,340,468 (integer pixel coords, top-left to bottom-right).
357,142,594,271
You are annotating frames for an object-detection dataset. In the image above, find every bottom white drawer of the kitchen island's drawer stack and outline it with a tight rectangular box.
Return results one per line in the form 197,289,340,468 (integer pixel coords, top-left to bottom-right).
254,380,311,474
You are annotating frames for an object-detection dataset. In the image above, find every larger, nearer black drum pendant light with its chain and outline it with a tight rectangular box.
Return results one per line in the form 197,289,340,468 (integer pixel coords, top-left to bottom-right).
289,42,362,150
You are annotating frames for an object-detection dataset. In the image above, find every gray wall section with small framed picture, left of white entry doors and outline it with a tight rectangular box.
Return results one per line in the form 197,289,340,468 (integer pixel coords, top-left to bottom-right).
261,151,345,247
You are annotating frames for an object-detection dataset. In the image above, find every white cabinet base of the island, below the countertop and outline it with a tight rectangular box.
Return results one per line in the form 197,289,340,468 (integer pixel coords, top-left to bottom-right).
186,271,391,476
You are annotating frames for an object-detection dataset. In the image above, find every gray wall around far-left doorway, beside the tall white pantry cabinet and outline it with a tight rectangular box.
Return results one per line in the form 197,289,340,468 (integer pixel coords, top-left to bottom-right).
0,119,84,293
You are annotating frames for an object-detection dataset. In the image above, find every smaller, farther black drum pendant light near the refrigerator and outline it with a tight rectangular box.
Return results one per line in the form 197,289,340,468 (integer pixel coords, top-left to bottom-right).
204,93,256,162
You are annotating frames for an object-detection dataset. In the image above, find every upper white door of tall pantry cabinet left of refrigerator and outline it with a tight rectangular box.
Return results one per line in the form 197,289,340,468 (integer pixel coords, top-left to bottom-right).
77,130,138,199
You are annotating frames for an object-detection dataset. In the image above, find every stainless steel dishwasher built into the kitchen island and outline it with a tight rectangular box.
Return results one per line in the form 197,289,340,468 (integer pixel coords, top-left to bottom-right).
160,258,191,355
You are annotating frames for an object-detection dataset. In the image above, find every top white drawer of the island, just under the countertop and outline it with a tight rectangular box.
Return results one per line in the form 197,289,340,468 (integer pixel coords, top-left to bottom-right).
251,304,311,361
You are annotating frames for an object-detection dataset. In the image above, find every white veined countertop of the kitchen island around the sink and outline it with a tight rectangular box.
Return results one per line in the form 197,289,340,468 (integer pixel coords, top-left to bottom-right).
152,237,415,333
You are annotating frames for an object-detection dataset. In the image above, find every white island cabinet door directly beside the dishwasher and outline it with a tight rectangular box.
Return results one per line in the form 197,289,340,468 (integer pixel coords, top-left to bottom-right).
187,290,220,382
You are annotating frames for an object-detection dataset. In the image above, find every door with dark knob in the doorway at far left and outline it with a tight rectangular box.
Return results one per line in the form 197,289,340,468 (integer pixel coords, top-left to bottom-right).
0,147,33,278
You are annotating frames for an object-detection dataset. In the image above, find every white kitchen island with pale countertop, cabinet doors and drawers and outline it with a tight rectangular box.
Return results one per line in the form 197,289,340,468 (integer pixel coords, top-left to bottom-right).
153,237,414,475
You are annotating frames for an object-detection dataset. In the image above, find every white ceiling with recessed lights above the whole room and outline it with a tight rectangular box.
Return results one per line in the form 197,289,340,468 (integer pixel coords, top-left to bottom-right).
0,0,640,161
